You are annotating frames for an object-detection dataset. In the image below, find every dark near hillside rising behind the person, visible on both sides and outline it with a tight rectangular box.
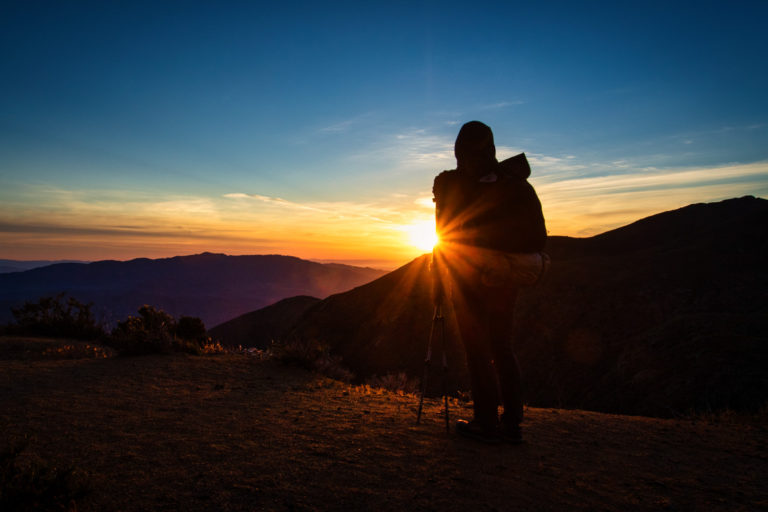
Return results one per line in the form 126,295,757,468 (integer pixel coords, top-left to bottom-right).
212,197,768,416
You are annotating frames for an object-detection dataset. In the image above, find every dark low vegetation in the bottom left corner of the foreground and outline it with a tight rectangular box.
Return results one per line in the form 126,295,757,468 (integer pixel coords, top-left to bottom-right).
0,443,88,512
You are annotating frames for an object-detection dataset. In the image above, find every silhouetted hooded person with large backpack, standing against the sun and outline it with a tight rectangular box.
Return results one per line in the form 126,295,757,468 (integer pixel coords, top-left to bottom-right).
433,121,547,442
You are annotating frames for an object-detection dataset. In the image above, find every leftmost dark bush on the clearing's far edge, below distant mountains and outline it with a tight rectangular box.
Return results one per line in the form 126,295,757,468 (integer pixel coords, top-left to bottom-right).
6,293,106,340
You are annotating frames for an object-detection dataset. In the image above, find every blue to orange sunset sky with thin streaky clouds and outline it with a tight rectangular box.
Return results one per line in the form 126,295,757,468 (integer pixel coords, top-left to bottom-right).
0,0,768,269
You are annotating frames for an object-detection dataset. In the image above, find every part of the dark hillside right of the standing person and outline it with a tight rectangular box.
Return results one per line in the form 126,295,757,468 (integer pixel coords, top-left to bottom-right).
517,197,768,415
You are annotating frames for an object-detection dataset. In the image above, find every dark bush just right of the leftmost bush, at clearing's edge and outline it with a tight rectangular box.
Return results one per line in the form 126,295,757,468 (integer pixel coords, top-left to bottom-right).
109,305,223,355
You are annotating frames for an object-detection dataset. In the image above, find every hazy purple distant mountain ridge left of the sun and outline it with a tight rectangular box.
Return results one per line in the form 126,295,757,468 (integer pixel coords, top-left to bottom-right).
0,253,385,325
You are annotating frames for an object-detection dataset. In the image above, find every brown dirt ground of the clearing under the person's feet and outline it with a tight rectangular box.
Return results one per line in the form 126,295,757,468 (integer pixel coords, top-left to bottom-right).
0,338,768,511
